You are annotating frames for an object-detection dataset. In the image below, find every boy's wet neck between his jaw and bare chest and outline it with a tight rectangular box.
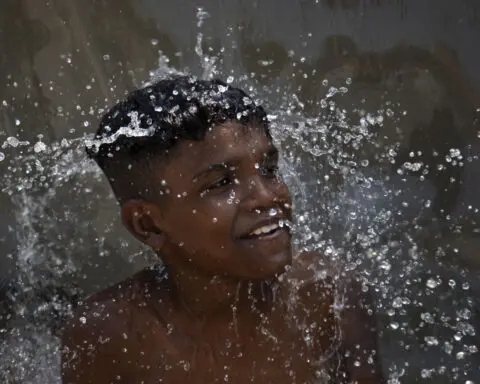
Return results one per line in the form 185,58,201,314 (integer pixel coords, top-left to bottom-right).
167,265,278,320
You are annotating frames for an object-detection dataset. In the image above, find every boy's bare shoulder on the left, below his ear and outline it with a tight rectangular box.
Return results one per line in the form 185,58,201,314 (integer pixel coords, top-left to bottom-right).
62,273,172,384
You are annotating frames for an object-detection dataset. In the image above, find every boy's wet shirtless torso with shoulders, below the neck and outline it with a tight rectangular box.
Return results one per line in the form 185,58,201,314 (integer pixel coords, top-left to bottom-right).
63,255,377,384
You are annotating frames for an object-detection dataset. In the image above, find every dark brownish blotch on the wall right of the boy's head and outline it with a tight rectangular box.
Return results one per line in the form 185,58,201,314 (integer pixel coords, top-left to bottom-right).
241,32,480,217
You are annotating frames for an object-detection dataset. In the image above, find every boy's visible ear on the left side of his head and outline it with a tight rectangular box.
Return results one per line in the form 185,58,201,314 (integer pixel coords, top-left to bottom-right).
122,200,166,251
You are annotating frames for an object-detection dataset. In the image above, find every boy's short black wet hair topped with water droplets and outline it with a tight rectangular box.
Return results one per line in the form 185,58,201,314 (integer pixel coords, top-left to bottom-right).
86,76,270,203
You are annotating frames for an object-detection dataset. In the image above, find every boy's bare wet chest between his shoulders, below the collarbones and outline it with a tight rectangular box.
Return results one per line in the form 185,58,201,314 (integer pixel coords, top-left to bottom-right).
145,310,334,384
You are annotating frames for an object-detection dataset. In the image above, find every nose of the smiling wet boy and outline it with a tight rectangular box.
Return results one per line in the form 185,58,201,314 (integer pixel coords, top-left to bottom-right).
244,175,291,212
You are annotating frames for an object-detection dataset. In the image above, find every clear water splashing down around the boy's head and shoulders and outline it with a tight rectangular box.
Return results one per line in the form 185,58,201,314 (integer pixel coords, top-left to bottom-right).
0,3,480,383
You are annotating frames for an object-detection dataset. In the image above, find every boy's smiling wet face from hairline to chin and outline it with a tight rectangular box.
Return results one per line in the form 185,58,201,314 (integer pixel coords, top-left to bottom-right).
144,123,292,279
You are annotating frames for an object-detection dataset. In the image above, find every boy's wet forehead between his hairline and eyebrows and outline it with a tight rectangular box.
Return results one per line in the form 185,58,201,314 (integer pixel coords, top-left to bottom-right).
167,123,274,174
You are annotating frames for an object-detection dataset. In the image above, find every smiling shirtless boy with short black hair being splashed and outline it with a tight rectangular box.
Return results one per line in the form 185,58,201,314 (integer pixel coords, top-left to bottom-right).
62,76,381,384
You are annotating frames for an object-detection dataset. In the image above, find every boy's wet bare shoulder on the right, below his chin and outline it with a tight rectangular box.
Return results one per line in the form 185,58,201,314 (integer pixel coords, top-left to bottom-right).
286,253,384,384
